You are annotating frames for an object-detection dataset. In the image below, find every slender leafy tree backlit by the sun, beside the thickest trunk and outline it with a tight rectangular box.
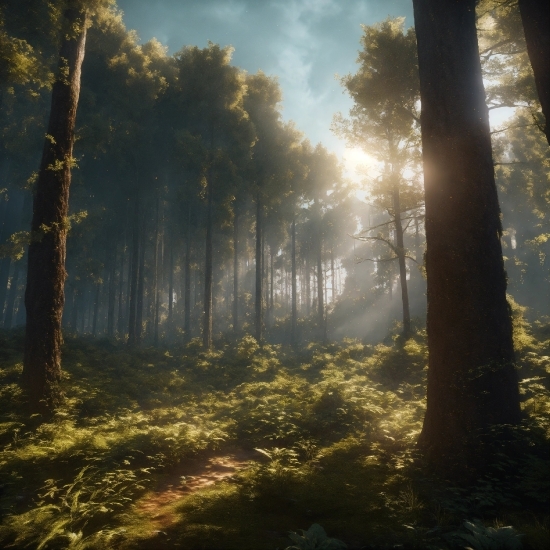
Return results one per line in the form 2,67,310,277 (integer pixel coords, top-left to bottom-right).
333,18,421,334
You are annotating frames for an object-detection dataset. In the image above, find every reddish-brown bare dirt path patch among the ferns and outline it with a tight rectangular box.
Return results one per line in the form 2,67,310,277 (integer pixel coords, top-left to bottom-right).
137,450,258,529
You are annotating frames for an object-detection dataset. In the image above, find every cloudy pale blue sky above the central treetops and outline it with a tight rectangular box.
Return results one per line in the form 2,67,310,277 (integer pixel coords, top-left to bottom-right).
117,0,413,179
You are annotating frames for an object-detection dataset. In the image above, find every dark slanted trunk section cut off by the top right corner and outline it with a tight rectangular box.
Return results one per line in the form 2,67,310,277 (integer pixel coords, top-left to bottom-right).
519,0,550,145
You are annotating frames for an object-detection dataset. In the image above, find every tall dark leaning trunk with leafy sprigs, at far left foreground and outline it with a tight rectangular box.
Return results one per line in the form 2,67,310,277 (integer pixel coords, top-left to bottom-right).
23,2,87,413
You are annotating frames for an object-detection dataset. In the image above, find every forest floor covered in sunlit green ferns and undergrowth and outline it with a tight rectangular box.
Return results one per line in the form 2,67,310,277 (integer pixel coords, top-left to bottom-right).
0,317,550,550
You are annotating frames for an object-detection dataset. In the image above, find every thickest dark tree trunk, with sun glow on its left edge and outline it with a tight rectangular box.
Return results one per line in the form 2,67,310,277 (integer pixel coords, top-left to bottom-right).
413,0,520,468
